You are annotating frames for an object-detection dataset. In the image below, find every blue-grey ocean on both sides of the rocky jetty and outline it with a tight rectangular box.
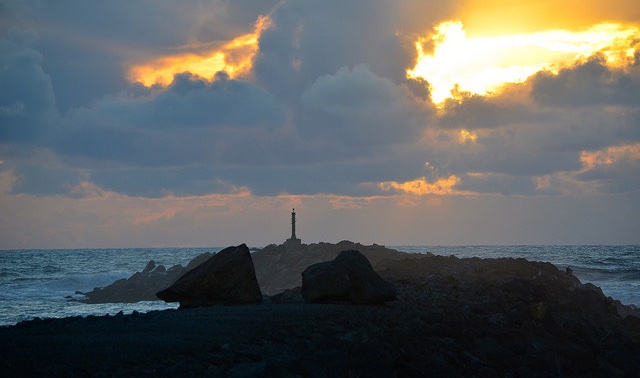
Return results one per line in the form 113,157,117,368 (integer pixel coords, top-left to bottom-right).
0,245,640,326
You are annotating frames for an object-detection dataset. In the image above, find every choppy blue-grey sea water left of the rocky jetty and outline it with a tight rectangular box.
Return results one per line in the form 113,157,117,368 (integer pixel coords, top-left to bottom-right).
0,248,221,326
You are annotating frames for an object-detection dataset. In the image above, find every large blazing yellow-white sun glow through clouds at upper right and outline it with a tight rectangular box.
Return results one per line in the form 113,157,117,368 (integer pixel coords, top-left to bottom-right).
407,21,640,104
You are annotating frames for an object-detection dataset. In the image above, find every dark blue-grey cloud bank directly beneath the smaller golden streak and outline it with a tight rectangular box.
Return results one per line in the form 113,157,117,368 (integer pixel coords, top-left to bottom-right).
76,72,283,130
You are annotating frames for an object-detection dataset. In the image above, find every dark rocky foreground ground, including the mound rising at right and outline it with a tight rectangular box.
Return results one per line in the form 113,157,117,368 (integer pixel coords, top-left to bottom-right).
0,254,640,377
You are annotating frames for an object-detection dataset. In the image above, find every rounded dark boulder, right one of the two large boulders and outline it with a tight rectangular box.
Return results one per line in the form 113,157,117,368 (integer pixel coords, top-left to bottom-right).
302,250,396,304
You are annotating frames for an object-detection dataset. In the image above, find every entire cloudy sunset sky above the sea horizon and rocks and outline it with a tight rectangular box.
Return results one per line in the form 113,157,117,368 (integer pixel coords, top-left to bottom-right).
0,0,640,249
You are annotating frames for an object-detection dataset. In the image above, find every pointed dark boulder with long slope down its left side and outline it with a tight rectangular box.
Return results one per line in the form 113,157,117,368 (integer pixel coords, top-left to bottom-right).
156,244,262,308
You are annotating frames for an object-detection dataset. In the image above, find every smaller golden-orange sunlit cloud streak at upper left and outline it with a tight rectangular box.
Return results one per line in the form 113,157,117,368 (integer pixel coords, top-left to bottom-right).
128,16,269,87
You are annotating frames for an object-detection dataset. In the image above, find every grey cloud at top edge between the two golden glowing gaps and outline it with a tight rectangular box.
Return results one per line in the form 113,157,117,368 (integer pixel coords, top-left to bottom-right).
254,0,435,99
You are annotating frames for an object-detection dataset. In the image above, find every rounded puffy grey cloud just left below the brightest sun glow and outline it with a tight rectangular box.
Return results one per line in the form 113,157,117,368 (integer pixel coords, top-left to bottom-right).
300,65,429,147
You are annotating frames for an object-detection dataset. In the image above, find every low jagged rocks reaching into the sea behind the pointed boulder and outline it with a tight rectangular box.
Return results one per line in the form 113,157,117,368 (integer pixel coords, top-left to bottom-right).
76,253,211,303
